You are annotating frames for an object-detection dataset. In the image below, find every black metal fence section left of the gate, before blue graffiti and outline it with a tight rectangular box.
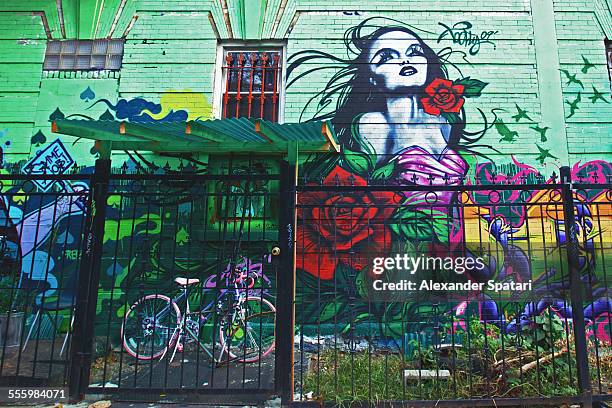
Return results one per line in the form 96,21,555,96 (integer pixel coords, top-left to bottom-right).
0,175,91,387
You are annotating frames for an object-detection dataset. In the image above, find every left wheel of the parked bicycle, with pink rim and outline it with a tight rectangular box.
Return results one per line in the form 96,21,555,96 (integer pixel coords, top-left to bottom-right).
121,295,181,360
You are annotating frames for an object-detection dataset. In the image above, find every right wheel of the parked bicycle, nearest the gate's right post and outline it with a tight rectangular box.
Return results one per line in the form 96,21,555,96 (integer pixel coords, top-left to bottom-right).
219,297,276,363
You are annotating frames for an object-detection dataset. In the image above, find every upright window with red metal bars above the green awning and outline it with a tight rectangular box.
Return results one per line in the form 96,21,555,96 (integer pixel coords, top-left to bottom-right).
222,50,281,122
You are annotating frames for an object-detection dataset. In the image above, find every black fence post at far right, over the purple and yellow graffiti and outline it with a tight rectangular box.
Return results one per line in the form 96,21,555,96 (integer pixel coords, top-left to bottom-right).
561,166,593,407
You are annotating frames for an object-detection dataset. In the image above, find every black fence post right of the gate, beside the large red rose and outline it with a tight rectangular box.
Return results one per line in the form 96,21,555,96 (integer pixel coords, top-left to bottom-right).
274,161,297,406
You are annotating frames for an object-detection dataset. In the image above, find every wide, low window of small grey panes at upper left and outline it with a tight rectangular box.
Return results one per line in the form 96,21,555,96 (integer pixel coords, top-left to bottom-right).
43,39,125,71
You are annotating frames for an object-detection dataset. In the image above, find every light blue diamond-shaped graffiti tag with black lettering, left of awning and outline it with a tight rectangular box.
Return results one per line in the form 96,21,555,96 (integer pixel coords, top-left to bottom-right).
22,139,75,191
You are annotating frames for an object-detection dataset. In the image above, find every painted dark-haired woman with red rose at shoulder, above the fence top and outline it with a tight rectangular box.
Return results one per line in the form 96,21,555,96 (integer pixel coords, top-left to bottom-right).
288,17,486,198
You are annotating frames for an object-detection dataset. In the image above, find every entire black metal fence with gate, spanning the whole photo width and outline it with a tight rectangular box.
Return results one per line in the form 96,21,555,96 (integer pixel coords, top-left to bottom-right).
0,158,612,406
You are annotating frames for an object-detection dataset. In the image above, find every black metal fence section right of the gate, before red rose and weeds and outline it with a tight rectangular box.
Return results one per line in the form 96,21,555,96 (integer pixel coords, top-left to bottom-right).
294,169,612,407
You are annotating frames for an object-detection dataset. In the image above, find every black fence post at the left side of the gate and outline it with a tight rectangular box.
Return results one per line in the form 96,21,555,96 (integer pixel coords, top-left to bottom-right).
68,158,111,401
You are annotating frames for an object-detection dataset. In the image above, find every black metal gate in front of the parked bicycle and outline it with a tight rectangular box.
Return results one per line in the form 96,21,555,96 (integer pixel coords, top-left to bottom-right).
67,158,288,401
